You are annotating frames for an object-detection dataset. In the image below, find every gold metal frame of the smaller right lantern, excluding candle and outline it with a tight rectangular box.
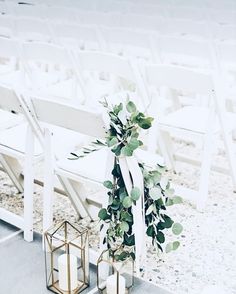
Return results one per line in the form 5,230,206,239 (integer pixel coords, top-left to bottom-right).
97,247,134,294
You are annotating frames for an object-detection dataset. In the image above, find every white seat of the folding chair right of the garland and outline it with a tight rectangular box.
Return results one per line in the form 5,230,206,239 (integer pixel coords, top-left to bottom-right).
159,106,219,134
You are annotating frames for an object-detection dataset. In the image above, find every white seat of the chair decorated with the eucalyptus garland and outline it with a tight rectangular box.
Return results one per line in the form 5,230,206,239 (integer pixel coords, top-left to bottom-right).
56,147,164,183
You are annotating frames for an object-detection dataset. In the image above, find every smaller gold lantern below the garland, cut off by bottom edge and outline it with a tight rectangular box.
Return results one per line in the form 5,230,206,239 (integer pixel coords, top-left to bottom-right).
97,248,134,294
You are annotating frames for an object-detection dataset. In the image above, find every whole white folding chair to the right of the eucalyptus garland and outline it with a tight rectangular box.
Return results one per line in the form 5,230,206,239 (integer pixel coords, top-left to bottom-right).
145,65,236,209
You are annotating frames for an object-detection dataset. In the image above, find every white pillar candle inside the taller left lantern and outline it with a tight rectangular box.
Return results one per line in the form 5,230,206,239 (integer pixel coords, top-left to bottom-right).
58,254,78,291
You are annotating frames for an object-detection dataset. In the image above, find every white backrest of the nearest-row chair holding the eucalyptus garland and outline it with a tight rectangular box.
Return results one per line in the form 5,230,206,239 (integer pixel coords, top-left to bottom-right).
32,98,106,138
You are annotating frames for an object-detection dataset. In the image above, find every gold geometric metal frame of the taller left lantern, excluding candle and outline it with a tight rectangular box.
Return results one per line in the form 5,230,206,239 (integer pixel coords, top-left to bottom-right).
44,221,90,294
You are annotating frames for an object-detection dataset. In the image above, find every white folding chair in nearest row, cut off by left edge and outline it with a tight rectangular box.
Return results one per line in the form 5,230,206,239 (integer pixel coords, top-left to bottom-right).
0,86,91,241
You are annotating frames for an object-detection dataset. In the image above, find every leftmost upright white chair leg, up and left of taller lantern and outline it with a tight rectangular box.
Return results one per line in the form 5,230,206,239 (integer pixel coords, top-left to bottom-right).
24,127,34,242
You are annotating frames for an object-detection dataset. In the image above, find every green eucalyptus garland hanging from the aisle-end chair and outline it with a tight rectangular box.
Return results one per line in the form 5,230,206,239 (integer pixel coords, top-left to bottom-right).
97,101,183,260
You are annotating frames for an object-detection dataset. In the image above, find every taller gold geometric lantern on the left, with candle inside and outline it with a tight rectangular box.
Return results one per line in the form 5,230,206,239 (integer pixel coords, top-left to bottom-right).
44,221,89,294
